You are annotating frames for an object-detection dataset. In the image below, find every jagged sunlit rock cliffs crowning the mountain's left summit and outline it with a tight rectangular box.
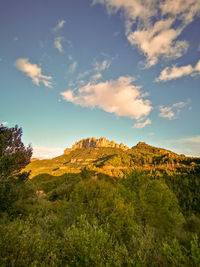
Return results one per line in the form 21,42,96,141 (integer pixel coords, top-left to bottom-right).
64,137,129,154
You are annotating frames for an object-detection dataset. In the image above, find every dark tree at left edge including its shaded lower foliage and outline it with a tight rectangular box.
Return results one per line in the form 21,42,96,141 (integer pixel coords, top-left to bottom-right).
0,125,32,213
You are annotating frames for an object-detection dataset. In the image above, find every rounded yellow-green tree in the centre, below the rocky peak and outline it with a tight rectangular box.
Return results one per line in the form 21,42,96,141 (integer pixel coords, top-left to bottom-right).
70,179,135,242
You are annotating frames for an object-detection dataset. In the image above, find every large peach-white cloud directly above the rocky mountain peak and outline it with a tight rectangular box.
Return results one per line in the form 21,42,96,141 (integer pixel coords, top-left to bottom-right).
61,76,152,120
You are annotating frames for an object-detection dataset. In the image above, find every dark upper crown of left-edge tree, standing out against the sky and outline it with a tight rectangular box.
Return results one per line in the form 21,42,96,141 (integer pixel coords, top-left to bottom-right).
0,125,32,178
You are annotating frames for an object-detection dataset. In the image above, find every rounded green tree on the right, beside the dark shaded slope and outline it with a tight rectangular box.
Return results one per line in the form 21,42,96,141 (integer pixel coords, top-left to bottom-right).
120,171,184,236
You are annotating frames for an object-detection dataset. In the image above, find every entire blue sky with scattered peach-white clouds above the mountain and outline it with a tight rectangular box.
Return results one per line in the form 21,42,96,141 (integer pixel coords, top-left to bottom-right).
0,0,200,158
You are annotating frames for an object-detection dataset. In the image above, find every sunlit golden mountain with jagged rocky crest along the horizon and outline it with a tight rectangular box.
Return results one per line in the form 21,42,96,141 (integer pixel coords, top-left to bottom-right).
25,137,200,177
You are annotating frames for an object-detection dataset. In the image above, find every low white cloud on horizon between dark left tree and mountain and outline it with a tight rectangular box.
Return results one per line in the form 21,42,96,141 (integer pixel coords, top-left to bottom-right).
32,146,63,159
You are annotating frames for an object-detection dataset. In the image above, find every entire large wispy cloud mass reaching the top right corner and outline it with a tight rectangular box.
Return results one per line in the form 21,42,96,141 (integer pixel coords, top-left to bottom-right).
93,0,200,67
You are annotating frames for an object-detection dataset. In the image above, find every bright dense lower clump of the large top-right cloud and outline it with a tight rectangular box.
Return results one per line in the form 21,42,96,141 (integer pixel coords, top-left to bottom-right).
127,19,188,67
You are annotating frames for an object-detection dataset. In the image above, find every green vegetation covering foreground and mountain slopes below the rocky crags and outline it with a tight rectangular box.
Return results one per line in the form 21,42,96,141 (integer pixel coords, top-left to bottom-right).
0,125,200,267
